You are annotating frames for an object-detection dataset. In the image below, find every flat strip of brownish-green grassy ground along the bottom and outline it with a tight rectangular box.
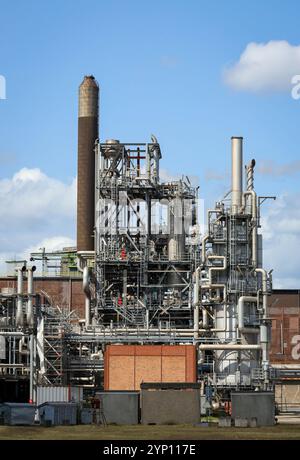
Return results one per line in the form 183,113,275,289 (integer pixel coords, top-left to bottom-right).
0,416,300,440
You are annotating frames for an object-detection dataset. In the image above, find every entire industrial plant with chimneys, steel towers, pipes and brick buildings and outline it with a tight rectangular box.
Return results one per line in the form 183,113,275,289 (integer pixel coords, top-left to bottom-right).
0,76,300,426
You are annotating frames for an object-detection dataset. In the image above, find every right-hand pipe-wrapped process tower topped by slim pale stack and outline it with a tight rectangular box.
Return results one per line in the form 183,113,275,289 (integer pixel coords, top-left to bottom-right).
195,137,272,389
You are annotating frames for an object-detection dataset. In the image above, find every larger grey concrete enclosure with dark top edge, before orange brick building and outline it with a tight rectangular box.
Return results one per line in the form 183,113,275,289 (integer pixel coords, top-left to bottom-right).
141,389,200,425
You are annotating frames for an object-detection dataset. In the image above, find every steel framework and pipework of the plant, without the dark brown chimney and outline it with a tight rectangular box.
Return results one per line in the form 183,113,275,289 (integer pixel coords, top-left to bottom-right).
0,137,272,398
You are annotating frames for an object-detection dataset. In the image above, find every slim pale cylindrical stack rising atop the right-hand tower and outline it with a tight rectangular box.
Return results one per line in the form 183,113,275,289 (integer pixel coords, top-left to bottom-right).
231,137,243,214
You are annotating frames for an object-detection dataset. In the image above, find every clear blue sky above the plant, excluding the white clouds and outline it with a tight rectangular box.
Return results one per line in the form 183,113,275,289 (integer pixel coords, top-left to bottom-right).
0,0,300,287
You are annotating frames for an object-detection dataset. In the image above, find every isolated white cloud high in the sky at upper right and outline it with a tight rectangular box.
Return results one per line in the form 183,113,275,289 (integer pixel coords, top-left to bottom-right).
224,40,300,92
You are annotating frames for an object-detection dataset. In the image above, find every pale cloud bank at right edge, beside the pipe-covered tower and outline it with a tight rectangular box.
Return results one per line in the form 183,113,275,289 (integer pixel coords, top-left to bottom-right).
262,194,300,289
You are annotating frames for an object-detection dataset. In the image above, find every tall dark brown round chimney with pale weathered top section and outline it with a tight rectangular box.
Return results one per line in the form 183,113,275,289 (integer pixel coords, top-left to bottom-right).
77,75,99,251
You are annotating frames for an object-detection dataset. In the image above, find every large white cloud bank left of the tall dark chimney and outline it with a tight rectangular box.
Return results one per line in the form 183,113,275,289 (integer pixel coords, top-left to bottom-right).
0,168,76,271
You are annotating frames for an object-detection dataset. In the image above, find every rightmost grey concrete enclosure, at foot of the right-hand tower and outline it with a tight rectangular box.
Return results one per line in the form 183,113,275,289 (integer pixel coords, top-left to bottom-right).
231,392,275,426
